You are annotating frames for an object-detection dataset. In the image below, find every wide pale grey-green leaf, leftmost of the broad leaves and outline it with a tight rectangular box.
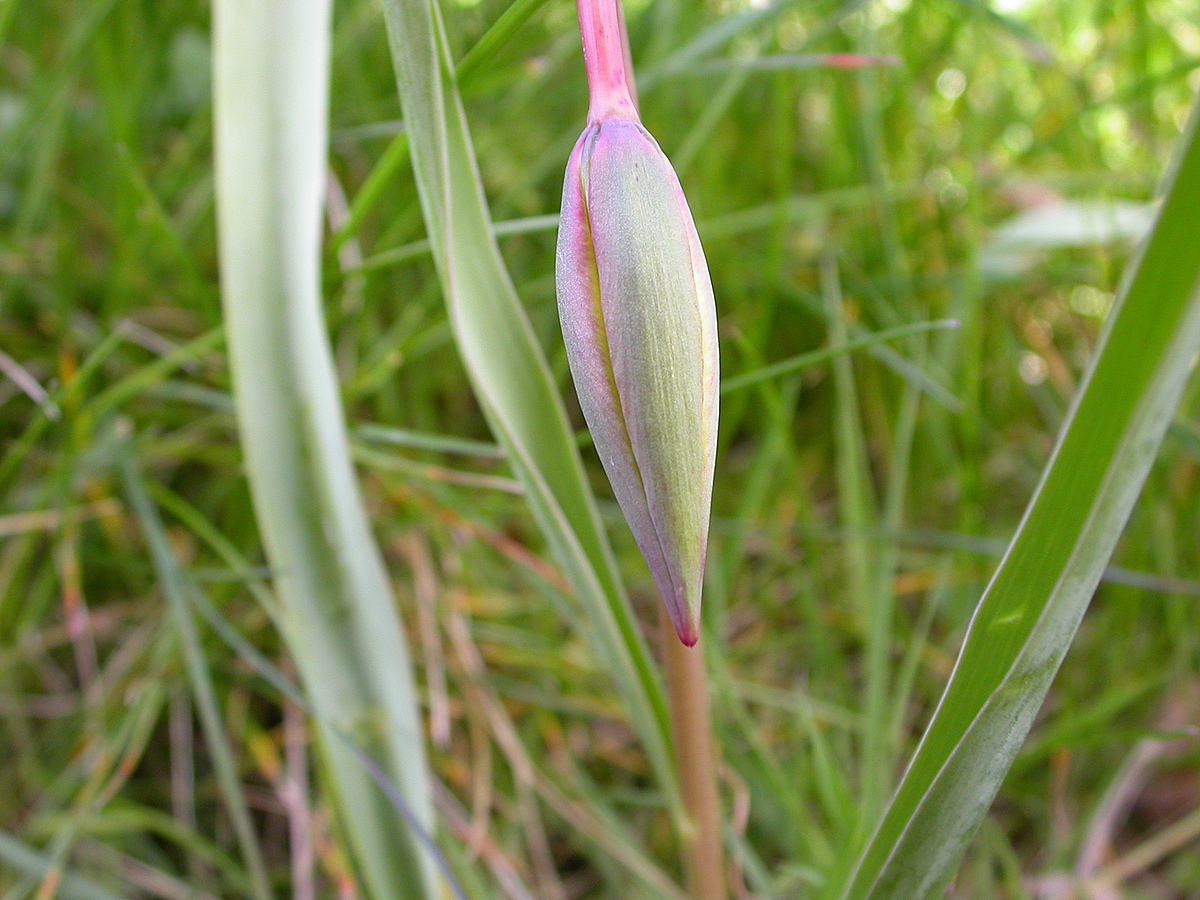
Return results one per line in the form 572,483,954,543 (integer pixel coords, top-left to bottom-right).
214,7,438,899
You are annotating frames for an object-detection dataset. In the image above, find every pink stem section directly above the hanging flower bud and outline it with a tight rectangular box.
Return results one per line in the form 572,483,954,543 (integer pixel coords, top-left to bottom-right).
576,0,637,122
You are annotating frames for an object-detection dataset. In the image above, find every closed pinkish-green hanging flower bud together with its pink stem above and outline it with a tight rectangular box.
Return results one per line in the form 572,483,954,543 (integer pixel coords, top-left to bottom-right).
557,0,718,646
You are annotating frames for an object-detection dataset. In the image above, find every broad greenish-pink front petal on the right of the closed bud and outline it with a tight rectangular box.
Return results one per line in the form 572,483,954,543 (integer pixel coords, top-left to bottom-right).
587,119,716,644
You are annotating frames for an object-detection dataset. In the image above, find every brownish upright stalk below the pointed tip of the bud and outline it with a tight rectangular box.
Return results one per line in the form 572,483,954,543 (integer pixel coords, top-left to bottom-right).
659,605,726,900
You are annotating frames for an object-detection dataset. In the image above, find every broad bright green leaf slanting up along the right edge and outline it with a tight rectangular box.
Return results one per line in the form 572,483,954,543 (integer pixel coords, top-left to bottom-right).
829,98,1200,900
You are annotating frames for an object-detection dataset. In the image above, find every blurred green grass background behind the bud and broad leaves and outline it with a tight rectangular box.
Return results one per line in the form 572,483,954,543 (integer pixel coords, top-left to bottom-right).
0,0,1200,900
